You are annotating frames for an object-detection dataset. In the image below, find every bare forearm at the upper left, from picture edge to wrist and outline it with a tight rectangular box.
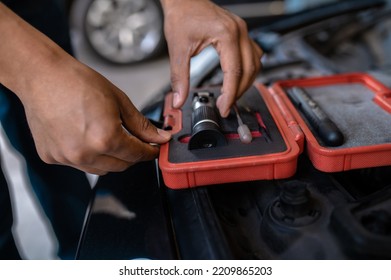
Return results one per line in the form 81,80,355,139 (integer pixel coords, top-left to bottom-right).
0,3,75,102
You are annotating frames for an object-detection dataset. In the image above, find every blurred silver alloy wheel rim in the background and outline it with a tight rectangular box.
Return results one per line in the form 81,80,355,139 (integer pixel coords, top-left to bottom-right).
83,0,166,64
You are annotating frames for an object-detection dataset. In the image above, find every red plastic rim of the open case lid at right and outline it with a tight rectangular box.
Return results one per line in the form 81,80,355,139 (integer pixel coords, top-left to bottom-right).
269,73,391,172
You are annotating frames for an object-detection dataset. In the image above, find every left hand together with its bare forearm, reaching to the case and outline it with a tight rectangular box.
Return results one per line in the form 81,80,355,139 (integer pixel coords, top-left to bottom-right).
0,2,171,175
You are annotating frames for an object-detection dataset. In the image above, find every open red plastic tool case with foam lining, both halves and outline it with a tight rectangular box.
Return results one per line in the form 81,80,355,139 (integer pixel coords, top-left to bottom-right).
159,73,391,189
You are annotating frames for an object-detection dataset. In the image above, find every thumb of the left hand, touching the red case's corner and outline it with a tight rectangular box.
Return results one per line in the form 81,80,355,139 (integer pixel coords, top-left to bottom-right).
120,92,171,144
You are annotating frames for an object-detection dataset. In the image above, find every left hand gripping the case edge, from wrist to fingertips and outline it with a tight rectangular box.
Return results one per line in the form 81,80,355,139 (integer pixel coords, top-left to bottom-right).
23,63,171,175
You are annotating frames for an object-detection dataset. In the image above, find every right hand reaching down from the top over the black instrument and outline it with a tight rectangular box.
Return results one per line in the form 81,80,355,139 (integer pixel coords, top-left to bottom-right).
161,0,263,117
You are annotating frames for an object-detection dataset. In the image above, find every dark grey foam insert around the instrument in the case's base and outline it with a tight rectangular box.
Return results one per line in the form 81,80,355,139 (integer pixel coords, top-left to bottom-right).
168,87,287,163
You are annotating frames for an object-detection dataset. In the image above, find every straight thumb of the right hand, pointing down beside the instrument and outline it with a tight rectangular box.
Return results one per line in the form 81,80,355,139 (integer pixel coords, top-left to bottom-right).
170,48,190,108
